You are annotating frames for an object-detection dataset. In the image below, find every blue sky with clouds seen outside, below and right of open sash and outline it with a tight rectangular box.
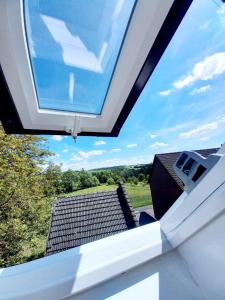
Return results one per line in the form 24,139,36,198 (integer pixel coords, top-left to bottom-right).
43,0,225,170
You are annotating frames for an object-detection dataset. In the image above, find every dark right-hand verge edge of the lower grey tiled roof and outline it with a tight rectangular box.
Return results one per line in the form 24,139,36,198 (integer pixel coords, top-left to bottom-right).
117,181,138,229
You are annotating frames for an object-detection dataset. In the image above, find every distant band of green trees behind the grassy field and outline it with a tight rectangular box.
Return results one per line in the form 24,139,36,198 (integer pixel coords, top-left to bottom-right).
44,164,152,196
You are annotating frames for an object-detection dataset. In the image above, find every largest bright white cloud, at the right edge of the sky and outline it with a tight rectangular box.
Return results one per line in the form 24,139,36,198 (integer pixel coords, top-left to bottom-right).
174,52,225,89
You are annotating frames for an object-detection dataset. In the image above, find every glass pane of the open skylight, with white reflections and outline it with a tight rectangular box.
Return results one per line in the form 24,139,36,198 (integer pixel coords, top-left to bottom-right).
25,0,135,114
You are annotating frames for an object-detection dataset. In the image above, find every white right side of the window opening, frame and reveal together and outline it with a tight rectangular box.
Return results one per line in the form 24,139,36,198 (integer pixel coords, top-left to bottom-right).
160,157,225,300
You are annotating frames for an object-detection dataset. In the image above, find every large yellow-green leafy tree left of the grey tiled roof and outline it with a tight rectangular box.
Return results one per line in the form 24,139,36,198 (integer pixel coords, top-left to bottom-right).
0,129,51,266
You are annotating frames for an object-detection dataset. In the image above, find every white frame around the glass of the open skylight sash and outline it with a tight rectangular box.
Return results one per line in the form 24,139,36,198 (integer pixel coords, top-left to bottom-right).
0,0,173,133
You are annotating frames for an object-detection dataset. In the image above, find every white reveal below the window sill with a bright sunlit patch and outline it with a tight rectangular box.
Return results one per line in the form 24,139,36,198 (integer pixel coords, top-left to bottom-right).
68,251,205,300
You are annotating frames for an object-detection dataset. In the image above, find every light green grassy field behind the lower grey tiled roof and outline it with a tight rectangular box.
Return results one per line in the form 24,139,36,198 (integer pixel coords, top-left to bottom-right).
60,184,152,208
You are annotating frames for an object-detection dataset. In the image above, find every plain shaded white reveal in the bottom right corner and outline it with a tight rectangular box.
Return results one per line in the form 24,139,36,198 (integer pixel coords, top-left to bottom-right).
178,213,225,300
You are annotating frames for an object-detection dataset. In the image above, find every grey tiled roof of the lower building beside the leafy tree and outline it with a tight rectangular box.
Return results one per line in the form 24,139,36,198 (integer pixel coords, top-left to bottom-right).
45,184,137,255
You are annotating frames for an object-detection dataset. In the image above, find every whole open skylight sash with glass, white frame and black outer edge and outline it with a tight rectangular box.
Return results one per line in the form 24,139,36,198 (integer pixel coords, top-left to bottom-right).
0,0,191,137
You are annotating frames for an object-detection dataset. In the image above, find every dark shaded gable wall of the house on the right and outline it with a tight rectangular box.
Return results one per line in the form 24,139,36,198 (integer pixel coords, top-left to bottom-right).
150,157,183,219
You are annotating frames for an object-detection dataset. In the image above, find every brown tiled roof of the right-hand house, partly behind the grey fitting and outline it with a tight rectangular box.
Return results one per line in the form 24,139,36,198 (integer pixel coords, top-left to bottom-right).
155,148,219,189
